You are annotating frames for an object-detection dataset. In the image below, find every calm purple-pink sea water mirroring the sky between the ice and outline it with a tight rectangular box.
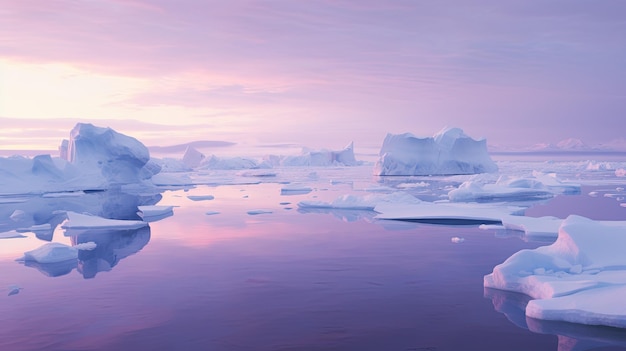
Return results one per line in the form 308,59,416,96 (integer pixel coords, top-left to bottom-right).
0,166,626,351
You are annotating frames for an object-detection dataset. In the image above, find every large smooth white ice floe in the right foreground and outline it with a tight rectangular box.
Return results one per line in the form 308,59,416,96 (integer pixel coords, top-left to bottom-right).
484,215,626,328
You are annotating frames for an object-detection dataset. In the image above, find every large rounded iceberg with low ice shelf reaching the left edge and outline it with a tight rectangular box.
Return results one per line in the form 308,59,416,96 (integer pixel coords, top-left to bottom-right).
0,123,160,195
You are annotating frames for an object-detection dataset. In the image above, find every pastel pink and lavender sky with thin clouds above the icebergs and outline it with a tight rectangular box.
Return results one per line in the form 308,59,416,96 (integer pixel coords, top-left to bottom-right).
0,0,626,153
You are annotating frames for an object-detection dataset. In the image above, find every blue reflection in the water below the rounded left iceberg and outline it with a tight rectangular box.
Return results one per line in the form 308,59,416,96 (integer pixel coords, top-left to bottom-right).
0,189,161,279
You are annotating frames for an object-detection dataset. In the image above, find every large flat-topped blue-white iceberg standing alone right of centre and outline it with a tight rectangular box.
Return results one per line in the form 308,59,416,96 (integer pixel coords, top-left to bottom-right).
374,128,498,176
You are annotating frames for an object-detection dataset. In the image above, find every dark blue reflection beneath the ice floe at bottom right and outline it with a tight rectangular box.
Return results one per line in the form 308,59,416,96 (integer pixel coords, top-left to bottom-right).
484,288,626,351
